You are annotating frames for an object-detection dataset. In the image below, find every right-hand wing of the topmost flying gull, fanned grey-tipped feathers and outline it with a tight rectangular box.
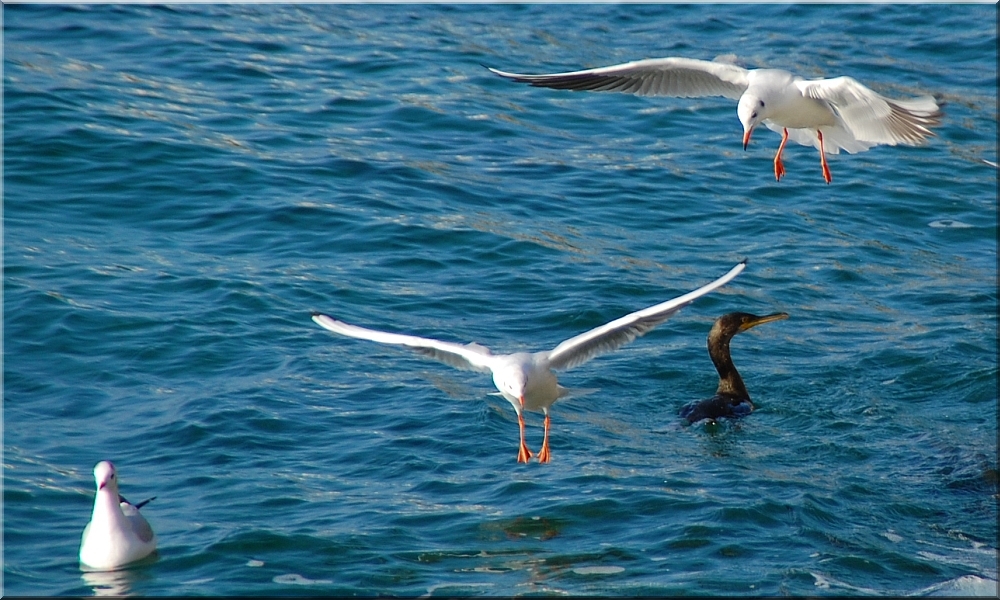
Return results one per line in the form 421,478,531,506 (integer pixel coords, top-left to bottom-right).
796,77,944,146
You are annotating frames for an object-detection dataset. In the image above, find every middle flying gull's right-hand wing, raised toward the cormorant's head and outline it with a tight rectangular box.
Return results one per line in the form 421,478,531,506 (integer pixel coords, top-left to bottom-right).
548,260,747,369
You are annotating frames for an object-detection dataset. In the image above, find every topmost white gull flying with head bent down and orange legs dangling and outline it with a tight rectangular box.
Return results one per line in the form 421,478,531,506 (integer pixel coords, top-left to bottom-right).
487,57,943,183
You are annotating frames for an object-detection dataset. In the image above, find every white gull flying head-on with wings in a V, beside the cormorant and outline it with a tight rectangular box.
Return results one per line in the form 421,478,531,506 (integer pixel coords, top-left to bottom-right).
313,260,746,463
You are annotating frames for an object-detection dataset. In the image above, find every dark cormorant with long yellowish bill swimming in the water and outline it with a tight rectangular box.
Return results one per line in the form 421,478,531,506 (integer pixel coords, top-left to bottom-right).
680,312,788,423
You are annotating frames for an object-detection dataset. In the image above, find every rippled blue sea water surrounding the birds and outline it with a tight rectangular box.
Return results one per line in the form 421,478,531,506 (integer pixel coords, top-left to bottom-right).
3,4,998,596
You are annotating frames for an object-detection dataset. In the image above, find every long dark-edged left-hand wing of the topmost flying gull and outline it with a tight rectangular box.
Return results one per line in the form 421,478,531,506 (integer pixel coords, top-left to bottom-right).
487,58,749,100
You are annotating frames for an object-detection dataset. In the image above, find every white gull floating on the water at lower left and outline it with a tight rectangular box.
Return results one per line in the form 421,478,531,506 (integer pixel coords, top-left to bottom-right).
80,460,156,570
